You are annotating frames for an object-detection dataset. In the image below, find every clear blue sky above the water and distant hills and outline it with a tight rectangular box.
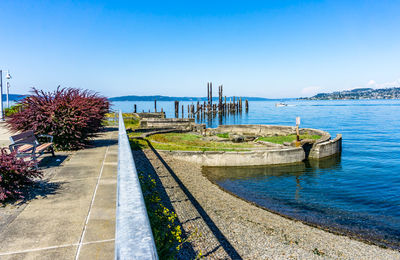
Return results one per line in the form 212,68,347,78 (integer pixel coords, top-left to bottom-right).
0,0,400,98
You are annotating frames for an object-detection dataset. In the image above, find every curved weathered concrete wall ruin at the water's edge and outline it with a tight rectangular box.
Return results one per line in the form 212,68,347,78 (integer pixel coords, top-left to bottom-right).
135,118,342,166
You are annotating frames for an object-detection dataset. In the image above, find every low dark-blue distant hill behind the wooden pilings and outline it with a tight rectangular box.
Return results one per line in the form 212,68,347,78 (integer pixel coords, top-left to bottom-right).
108,95,270,101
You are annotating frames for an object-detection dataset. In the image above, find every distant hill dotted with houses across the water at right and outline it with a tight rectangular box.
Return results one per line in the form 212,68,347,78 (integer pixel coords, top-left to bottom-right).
300,88,400,100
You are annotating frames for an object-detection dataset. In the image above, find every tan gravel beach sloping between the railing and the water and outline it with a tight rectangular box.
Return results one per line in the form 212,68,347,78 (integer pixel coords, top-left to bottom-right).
134,147,400,259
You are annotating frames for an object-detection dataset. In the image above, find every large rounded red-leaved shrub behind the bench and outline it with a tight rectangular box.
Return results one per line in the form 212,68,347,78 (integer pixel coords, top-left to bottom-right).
8,87,109,150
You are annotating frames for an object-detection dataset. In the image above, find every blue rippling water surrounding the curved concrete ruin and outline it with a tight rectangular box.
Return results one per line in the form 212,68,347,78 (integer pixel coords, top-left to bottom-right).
114,100,400,248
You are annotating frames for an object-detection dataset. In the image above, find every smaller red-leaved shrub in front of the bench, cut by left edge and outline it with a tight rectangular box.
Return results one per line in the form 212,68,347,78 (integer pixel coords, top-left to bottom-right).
0,148,42,202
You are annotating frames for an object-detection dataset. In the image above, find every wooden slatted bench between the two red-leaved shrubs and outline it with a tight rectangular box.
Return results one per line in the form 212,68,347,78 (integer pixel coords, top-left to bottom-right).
9,130,55,167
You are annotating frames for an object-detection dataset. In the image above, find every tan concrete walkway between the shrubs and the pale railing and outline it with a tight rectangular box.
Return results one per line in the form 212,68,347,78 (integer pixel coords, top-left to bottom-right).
0,129,118,259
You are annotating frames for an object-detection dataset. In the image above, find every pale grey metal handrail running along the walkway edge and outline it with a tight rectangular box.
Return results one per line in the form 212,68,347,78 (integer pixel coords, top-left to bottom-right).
115,111,158,259
